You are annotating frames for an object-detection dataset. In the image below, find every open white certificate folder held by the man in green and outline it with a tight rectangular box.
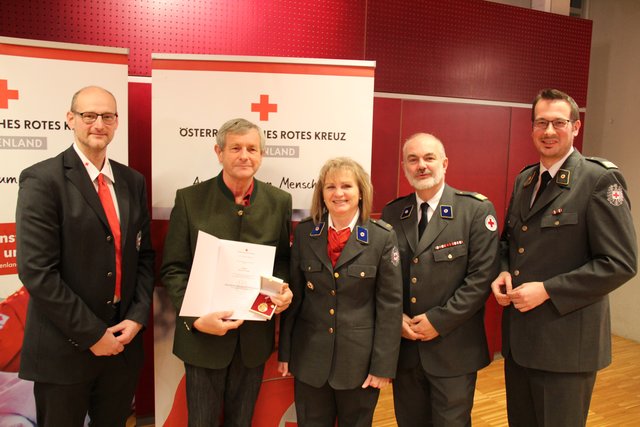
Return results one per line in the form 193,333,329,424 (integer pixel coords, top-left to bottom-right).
180,231,276,321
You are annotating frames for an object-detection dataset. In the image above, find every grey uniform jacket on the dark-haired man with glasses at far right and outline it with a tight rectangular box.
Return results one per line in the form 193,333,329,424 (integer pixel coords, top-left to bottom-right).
502,151,637,372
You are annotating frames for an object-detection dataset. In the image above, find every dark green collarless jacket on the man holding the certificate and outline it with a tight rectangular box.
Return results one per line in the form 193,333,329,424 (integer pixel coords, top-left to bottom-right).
160,173,291,369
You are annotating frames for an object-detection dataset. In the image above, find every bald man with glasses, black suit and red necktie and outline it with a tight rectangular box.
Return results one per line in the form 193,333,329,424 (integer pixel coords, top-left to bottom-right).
16,86,153,427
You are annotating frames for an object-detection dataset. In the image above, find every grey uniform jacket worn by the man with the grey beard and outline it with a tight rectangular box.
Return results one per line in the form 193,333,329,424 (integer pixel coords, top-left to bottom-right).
382,185,499,377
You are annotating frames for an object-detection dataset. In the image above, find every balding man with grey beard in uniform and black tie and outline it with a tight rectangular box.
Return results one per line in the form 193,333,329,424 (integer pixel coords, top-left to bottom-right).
382,133,498,427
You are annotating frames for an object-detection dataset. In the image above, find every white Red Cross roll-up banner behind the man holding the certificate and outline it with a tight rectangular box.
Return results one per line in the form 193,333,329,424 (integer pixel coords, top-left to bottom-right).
152,54,375,427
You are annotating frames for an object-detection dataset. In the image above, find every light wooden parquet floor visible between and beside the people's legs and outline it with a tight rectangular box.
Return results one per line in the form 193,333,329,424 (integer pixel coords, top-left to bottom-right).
373,336,640,427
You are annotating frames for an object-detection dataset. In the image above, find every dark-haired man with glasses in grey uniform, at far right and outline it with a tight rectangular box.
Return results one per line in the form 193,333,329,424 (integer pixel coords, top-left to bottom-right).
491,89,637,427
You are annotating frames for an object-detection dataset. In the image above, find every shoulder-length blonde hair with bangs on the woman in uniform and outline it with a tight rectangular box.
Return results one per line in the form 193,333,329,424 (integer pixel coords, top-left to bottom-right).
311,157,373,224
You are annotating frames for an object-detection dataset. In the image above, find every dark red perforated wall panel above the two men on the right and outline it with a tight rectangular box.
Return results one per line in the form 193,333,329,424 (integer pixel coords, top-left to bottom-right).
366,0,591,106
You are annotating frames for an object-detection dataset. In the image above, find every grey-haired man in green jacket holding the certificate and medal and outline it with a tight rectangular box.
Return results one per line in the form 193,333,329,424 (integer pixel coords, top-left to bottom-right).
161,119,292,427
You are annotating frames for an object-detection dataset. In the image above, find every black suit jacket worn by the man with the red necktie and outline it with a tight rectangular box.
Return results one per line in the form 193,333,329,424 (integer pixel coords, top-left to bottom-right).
16,147,153,384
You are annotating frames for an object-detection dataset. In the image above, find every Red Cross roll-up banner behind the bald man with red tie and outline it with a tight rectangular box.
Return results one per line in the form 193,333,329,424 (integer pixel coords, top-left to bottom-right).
0,37,129,425
